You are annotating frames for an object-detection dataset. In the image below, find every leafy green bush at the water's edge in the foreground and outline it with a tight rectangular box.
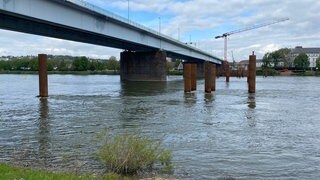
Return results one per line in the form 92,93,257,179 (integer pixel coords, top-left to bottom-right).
99,133,172,175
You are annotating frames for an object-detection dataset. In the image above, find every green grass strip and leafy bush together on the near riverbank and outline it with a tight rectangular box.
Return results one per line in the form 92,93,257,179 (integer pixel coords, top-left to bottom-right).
0,131,173,180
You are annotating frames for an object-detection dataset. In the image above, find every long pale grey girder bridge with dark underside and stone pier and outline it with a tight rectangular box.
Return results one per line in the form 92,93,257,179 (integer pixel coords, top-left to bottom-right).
0,0,222,81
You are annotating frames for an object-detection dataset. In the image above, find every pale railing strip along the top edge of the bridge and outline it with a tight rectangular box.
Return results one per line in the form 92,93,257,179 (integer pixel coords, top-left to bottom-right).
65,0,220,60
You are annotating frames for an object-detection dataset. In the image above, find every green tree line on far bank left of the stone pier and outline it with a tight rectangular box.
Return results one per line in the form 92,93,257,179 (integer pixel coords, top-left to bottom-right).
0,56,120,71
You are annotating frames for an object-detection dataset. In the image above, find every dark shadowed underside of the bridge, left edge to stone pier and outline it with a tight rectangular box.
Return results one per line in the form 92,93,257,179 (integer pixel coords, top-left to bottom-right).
0,10,155,51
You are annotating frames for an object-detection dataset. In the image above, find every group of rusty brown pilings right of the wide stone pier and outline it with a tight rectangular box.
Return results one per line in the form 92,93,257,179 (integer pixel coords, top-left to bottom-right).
183,52,256,93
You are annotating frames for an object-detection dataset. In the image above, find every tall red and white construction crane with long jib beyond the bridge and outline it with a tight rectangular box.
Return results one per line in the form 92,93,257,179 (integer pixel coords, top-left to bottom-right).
215,18,289,61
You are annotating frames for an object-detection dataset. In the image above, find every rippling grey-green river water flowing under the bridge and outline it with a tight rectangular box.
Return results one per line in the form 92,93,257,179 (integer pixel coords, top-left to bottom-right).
0,75,320,179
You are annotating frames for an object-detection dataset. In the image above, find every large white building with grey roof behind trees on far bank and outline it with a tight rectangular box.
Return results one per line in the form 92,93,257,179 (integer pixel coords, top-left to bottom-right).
290,46,320,68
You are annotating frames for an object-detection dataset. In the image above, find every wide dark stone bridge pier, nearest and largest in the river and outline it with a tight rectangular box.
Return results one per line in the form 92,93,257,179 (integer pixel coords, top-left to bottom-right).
120,51,167,81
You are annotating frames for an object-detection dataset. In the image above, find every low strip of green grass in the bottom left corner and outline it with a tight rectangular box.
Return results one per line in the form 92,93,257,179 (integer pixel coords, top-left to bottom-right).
0,163,129,180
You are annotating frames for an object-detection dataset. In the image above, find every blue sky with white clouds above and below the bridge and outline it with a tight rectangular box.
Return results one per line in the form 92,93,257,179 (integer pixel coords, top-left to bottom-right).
0,0,320,61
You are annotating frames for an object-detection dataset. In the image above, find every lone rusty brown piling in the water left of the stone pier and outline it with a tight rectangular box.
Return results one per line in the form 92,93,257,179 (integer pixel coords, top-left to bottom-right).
38,54,48,97
